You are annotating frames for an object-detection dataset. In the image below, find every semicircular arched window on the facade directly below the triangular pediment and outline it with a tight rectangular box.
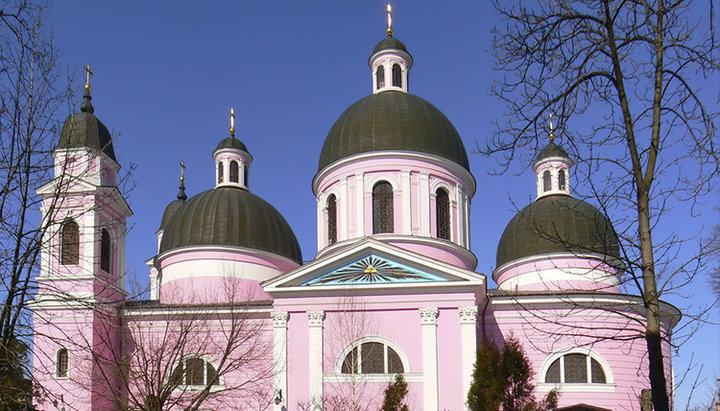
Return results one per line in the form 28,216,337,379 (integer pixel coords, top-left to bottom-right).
340,341,405,374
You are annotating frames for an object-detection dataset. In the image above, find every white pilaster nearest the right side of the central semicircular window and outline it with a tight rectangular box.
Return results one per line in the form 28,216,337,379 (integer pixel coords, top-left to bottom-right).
420,307,440,411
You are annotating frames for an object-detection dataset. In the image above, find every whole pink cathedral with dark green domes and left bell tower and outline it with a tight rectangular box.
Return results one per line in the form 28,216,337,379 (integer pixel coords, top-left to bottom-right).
31,26,680,411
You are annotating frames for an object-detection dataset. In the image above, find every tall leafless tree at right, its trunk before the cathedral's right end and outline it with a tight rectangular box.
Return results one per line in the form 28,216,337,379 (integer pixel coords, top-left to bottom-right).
478,0,720,411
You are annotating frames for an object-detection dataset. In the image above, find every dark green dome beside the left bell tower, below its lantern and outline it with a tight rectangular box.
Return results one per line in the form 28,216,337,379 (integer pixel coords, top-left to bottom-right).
160,187,302,264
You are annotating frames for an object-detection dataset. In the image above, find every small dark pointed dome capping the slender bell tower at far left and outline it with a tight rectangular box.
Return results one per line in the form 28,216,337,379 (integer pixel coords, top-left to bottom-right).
55,95,117,162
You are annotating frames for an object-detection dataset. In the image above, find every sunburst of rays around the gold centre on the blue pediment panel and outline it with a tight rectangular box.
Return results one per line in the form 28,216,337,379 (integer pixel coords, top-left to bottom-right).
313,256,427,284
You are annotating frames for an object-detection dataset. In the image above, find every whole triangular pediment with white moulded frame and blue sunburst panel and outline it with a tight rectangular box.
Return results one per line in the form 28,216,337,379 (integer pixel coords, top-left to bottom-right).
263,238,485,294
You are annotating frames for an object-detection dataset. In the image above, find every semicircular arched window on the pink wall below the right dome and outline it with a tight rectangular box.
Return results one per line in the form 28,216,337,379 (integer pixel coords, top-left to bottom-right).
544,353,607,384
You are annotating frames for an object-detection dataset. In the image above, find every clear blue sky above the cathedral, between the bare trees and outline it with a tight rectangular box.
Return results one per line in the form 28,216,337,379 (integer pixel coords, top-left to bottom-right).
48,0,720,406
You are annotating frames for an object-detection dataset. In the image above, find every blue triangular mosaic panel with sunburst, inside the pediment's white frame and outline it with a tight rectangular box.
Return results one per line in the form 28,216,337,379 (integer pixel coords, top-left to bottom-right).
302,255,447,285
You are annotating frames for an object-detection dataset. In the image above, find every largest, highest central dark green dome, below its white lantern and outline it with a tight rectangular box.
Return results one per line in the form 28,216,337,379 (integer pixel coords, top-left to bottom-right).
318,91,470,171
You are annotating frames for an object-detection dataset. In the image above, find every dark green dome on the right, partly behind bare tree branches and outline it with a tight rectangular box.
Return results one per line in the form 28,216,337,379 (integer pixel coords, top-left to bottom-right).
496,195,620,267
